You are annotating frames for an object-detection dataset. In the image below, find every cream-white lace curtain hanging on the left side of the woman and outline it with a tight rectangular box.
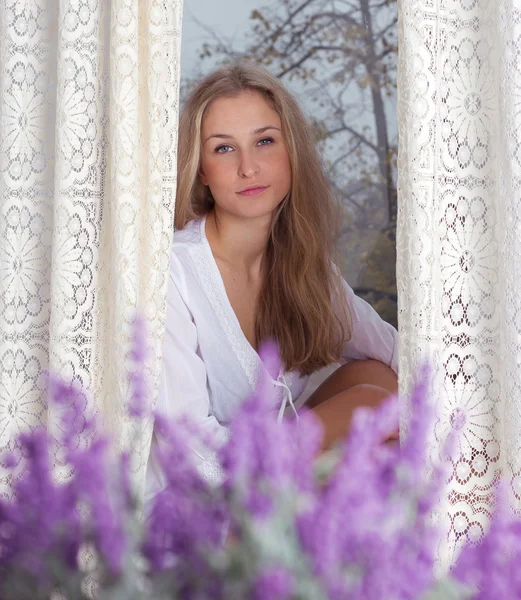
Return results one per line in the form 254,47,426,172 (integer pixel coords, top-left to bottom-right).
0,0,182,493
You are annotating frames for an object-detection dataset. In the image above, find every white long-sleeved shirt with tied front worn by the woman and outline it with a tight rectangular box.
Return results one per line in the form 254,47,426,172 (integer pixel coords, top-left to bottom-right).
146,219,398,498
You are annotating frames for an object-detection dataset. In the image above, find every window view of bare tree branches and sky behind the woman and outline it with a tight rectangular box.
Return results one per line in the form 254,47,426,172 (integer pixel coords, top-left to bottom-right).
181,0,397,326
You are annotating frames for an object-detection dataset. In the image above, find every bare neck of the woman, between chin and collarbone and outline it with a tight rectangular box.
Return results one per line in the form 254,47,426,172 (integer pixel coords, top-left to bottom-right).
206,209,271,274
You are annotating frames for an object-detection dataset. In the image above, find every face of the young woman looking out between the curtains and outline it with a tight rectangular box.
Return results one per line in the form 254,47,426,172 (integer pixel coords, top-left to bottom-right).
199,92,291,218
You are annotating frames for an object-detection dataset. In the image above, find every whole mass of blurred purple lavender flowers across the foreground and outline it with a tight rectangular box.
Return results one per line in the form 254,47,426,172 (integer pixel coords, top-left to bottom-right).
0,320,521,600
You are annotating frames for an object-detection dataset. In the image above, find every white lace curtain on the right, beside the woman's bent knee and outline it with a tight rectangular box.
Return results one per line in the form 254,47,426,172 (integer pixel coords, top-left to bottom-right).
397,0,521,565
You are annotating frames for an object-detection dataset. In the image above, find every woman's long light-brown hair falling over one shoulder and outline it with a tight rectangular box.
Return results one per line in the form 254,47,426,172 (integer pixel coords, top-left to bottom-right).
175,62,351,375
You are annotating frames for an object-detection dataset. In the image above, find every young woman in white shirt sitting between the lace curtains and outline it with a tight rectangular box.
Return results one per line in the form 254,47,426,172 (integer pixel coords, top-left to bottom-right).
144,63,397,500
